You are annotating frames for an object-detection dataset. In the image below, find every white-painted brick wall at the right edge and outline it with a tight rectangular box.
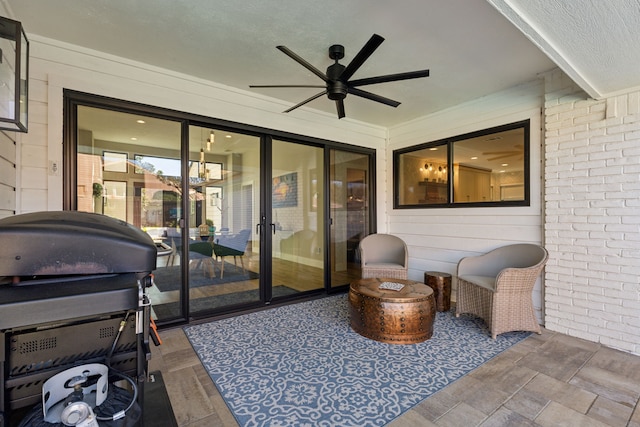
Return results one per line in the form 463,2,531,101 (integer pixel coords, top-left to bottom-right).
544,71,640,354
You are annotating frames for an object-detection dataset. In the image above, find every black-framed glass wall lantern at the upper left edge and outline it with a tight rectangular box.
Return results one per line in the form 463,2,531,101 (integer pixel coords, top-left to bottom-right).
0,17,29,132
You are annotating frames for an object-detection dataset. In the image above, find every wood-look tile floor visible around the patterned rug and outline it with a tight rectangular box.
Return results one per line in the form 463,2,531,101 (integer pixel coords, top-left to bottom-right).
150,310,640,427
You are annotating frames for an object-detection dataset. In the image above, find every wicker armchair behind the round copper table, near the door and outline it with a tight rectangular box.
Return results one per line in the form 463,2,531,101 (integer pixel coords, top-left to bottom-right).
360,234,409,279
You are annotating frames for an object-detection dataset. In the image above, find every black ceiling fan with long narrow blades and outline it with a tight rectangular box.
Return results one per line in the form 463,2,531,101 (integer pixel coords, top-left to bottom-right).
249,34,429,119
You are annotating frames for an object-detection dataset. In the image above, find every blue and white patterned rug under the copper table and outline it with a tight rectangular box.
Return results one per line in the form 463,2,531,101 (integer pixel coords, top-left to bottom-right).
184,295,529,427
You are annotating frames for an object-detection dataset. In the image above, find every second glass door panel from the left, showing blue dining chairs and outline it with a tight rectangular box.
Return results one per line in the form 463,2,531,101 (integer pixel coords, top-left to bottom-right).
186,126,260,314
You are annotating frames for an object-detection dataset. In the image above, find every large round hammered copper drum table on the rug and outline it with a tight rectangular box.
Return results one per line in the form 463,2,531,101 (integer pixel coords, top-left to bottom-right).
349,278,436,344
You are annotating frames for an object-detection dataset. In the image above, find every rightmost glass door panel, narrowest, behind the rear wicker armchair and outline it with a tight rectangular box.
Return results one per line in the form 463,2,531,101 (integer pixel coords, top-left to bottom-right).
329,149,371,287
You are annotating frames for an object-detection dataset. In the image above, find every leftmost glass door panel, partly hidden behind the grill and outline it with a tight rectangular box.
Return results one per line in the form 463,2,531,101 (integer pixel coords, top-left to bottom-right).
76,105,183,320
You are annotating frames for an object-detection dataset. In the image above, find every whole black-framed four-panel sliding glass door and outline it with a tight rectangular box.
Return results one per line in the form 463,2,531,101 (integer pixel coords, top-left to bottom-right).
64,94,373,323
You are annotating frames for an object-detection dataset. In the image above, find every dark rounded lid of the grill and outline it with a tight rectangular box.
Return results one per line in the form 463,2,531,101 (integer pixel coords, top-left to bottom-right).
0,211,157,276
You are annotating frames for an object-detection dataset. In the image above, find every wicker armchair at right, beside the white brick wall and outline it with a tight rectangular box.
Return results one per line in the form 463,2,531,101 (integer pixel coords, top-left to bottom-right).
456,244,549,339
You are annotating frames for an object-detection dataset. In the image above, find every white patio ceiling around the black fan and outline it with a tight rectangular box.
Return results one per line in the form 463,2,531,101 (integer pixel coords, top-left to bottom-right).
1,0,640,127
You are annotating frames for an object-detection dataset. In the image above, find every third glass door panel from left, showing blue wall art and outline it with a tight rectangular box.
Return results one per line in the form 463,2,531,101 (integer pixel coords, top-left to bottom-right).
271,140,325,298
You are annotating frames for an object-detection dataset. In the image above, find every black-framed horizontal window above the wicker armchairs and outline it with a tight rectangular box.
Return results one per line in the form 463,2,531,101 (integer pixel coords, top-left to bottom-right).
393,120,530,208
